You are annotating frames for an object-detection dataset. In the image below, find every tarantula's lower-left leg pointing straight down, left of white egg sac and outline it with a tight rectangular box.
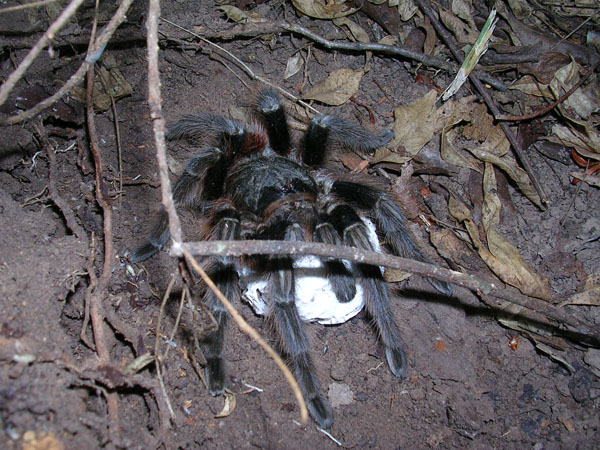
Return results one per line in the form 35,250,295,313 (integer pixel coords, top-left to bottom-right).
202,208,241,395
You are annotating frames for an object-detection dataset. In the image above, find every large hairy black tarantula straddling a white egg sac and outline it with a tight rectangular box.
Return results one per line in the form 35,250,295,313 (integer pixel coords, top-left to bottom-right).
130,89,452,428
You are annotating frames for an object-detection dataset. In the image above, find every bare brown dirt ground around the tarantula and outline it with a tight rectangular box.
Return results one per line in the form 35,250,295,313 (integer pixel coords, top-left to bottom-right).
0,0,600,449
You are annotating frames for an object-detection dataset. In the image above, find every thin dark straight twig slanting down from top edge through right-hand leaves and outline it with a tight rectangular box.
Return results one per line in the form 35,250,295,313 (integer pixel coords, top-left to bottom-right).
415,0,548,208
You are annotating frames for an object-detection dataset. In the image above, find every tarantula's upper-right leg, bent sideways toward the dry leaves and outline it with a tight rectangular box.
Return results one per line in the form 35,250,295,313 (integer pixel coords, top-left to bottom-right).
302,115,394,166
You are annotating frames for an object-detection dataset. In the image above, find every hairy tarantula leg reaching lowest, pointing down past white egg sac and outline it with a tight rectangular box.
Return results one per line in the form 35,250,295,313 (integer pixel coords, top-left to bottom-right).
269,224,333,428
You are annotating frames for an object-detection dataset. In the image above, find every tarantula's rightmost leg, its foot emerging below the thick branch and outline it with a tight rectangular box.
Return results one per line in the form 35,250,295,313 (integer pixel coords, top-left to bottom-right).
332,181,454,296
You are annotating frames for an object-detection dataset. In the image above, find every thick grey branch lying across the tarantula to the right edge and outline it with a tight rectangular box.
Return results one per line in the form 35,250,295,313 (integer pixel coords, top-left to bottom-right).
184,241,600,342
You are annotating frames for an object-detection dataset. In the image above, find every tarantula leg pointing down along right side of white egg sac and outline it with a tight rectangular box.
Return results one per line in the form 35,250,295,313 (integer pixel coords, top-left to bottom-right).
329,205,407,377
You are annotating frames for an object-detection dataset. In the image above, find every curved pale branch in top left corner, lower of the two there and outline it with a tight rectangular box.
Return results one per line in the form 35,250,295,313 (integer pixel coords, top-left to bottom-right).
0,0,134,125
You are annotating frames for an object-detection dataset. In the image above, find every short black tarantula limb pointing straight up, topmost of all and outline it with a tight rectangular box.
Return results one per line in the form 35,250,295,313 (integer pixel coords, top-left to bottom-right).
258,89,291,156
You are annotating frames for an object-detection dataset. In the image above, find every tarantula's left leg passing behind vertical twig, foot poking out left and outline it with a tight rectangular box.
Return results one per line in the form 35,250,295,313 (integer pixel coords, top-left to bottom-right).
129,147,226,263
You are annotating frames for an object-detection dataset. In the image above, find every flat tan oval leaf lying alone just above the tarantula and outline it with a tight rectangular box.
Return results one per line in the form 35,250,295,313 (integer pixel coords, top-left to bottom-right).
302,69,364,106
